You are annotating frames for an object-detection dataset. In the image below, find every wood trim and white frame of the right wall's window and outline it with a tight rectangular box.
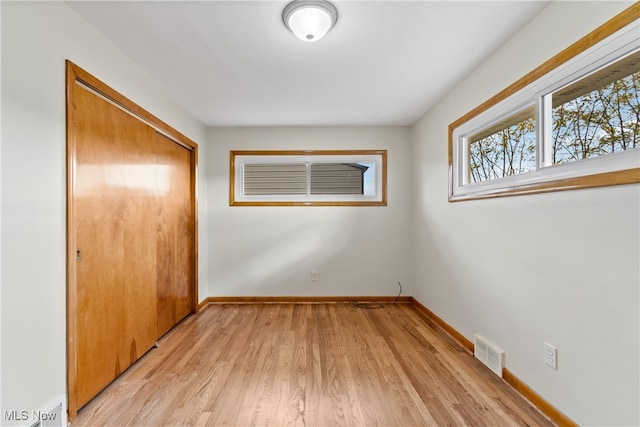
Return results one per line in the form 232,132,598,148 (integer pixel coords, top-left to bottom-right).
448,3,640,202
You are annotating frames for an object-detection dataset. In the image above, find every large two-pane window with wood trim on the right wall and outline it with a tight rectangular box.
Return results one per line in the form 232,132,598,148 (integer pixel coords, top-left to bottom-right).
449,7,640,201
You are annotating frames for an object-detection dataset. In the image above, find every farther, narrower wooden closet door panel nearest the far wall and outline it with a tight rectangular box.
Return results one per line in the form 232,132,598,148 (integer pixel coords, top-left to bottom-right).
155,134,194,336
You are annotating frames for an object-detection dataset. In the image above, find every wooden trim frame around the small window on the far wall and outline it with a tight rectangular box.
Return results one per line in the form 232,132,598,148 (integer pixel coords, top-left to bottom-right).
229,150,387,206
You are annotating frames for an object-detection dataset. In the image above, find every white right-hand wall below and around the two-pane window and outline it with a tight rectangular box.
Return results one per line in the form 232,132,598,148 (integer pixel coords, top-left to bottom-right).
412,2,640,425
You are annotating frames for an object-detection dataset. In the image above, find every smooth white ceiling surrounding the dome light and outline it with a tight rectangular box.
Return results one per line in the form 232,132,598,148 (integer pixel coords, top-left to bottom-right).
68,0,548,126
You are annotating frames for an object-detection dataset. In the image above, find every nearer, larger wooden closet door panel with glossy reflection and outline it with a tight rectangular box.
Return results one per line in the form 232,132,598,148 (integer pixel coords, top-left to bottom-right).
74,87,161,407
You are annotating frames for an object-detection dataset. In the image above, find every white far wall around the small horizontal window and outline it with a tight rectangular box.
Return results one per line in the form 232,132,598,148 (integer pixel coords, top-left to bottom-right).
207,127,412,296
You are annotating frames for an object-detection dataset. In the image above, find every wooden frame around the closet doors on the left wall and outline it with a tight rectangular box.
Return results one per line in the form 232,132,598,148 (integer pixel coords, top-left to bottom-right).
66,60,198,421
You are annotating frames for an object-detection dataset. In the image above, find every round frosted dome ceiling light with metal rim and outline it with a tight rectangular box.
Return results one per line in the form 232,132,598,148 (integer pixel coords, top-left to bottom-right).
282,0,338,42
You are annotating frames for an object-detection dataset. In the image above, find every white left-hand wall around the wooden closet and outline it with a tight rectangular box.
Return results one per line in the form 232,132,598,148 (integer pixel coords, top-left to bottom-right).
0,1,206,425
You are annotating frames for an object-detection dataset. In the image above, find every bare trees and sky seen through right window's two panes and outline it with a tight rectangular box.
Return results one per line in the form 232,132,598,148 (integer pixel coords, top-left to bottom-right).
469,67,640,182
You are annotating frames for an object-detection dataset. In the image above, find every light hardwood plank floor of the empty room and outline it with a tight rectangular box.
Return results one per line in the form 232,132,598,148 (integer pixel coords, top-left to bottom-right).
71,303,553,427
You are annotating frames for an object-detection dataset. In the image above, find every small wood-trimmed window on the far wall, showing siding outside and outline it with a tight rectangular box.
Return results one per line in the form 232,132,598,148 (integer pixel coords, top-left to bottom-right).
230,150,387,206
